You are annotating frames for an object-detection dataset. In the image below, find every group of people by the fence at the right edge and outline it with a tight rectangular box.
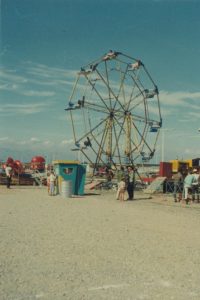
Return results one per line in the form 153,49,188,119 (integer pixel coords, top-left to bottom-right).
172,168,200,204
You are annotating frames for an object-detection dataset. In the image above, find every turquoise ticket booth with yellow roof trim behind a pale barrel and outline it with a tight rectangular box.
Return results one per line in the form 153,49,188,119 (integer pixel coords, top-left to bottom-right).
53,160,86,195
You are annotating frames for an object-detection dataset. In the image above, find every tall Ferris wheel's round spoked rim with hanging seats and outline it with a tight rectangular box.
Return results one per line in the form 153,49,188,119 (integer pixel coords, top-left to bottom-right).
66,50,162,166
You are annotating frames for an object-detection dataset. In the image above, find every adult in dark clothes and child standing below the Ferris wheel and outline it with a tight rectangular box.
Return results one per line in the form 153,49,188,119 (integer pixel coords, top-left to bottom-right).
116,166,136,201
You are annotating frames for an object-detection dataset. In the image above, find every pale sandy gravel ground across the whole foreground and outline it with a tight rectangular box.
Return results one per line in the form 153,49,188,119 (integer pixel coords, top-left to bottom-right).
0,187,200,300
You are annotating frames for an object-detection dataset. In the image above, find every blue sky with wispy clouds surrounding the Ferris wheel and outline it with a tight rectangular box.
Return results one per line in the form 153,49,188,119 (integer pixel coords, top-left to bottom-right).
0,0,200,161
